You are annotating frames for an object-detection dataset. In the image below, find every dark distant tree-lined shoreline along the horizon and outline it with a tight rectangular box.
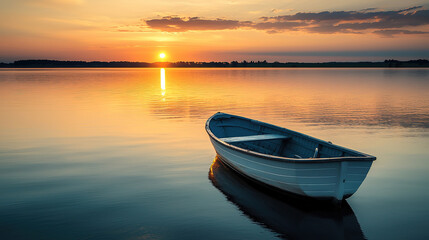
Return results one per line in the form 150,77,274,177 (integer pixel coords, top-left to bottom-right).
0,59,429,68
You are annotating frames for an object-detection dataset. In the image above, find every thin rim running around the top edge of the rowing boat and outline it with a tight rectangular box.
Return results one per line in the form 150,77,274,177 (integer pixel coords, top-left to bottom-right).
205,112,376,163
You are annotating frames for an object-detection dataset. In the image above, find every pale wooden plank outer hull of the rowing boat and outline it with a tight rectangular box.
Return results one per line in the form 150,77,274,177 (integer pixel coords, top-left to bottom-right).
210,136,372,201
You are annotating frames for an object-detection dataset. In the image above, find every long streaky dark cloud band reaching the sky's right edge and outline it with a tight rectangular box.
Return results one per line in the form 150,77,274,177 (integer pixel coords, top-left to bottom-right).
144,6,429,36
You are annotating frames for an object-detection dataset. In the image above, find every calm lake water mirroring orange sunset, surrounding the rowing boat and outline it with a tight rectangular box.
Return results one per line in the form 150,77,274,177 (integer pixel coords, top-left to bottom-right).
0,69,429,239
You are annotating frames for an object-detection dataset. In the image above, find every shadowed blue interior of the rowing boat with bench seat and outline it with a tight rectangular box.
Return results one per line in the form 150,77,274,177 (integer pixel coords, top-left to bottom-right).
209,114,365,158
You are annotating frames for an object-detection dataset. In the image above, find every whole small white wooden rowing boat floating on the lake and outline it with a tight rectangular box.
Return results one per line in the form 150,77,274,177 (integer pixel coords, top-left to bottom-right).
205,112,376,203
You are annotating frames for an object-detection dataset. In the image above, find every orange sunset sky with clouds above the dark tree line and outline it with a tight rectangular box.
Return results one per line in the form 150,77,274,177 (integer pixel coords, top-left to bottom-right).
0,0,429,62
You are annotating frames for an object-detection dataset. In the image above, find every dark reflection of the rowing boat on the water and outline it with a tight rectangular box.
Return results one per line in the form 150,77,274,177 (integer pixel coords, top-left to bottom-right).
209,157,365,239
